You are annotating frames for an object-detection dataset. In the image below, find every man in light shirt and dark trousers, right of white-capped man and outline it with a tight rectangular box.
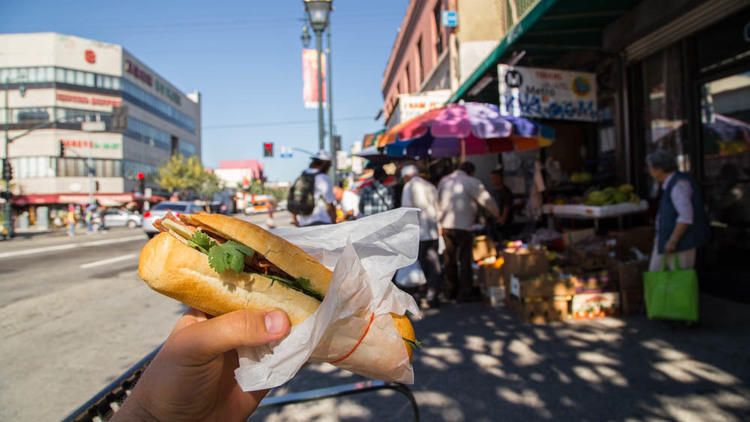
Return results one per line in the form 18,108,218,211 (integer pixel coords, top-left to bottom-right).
438,161,500,301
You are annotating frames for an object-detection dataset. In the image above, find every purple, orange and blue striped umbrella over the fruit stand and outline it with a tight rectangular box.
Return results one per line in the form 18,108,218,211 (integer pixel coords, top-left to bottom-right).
378,103,554,157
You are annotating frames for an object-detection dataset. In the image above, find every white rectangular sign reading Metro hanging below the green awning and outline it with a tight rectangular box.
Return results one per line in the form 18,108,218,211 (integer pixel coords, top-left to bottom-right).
497,64,599,122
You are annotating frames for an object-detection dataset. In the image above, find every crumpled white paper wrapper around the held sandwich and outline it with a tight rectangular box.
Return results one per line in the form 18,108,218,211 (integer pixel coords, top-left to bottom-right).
235,208,422,391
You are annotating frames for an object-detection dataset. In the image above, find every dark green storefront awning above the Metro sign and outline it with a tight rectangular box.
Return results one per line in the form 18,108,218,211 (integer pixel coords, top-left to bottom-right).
447,0,639,103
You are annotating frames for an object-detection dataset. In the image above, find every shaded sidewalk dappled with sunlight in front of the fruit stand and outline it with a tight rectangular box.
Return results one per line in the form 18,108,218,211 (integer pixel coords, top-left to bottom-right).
251,296,750,422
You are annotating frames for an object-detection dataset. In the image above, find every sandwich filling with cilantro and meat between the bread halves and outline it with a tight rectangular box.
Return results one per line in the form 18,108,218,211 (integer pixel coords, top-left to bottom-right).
154,213,323,301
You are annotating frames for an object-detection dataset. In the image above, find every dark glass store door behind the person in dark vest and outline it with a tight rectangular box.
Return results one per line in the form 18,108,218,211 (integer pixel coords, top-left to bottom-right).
700,70,750,301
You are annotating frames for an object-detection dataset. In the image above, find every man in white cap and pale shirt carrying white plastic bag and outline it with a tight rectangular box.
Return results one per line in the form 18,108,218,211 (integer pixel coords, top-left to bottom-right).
401,164,442,308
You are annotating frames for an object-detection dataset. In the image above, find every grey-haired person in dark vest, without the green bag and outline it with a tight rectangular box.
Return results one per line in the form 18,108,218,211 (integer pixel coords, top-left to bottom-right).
646,150,709,271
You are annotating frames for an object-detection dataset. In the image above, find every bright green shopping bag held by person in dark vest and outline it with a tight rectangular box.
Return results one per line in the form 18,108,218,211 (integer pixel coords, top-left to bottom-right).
643,254,698,321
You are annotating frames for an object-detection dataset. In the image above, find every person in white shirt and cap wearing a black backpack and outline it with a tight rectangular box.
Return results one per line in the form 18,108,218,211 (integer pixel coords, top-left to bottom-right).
287,150,336,227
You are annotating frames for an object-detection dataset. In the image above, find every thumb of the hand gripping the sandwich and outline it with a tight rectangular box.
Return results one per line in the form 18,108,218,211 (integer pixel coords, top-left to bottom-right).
165,309,290,365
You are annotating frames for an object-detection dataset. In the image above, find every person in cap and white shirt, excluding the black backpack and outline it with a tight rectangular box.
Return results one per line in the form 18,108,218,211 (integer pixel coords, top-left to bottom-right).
292,150,336,227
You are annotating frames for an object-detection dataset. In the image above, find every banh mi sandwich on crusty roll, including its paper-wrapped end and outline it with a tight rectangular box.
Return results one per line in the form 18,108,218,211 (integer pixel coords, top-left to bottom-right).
138,213,418,379
